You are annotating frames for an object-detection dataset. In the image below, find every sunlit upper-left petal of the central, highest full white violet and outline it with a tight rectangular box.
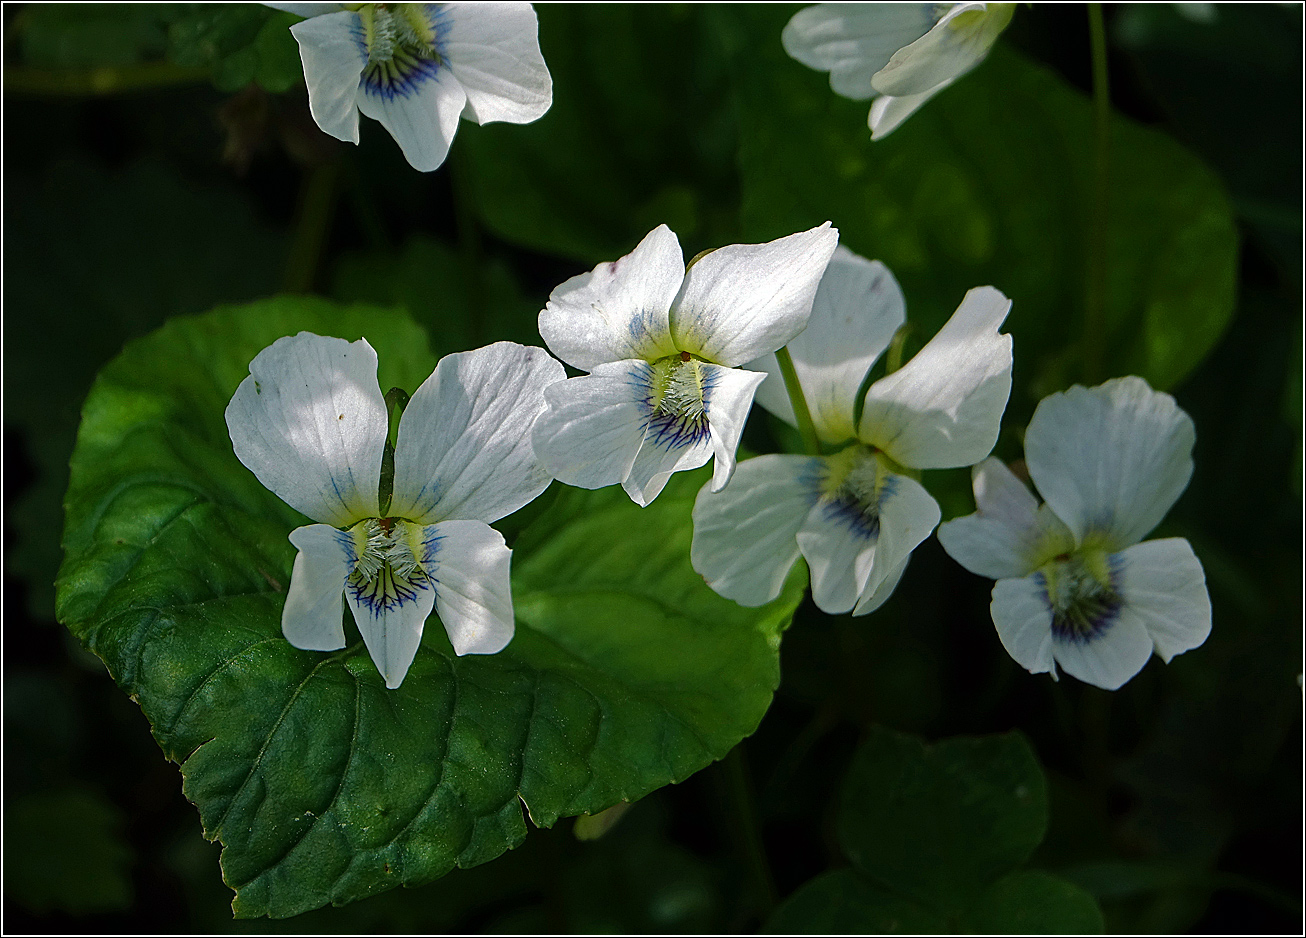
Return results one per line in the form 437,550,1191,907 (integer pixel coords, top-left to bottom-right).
539,225,684,371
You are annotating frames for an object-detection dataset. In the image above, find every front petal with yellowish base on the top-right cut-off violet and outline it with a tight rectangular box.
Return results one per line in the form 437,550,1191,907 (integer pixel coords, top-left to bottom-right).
871,3,1015,95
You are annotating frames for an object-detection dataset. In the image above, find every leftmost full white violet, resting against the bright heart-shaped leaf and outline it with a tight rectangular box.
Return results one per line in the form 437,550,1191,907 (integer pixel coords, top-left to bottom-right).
226,332,564,687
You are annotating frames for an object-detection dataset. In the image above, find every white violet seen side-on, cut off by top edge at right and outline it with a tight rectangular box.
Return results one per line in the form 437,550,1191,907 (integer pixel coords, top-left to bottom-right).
780,3,1016,140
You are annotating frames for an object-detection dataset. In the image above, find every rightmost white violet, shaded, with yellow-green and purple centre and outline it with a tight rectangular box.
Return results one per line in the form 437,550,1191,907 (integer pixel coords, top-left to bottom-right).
939,376,1211,690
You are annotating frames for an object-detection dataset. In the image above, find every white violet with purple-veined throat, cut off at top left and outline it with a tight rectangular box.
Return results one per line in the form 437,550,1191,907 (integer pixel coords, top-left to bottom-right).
268,3,554,172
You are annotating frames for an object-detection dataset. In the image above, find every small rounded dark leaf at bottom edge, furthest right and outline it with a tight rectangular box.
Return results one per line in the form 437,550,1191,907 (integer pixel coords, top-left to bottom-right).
965,870,1105,934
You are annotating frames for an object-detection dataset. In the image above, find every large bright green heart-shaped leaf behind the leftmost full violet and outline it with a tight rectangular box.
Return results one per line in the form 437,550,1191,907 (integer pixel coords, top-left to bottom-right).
57,299,802,916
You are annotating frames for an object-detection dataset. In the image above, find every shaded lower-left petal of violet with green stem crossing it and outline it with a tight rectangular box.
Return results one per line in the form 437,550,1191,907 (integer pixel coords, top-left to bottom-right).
690,455,820,606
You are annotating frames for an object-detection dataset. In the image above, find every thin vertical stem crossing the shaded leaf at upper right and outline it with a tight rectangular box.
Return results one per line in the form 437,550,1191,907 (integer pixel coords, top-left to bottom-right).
1084,3,1111,384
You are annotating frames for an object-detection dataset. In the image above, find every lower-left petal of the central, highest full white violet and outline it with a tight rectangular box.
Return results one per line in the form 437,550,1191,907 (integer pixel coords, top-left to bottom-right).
530,361,652,489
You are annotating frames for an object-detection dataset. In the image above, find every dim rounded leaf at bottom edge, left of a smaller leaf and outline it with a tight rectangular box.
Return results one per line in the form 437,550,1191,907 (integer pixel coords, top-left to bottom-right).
765,870,949,934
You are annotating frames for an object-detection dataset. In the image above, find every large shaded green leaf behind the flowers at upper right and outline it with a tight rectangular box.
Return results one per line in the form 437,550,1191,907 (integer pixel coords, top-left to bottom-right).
722,7,1238,398
